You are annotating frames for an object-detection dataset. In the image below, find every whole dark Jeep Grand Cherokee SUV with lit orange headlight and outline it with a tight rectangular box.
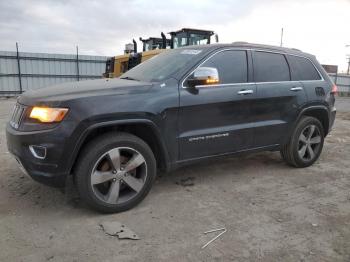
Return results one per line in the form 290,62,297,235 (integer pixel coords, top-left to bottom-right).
6,43,337,212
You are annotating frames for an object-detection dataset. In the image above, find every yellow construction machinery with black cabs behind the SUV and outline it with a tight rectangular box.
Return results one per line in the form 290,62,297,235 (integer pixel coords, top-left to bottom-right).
103,28,218,78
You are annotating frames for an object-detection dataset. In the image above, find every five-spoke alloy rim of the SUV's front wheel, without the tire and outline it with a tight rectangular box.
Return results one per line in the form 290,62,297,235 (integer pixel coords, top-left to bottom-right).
91,147,147,205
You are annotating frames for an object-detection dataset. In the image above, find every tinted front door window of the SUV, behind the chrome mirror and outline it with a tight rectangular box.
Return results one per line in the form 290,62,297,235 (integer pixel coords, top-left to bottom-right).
201,51,248,84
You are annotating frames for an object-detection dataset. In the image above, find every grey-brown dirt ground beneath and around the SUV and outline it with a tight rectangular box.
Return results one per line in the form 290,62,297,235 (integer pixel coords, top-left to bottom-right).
0,98,350,262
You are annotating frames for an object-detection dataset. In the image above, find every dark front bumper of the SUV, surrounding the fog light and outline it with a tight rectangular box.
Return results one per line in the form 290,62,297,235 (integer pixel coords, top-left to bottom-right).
6,124,68,187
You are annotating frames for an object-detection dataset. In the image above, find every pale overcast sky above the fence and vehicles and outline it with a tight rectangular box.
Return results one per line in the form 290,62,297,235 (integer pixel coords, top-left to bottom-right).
0,0,350,70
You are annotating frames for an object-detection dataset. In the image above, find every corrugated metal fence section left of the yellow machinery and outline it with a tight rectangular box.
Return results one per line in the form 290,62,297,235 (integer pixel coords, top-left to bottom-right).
0,45,107,96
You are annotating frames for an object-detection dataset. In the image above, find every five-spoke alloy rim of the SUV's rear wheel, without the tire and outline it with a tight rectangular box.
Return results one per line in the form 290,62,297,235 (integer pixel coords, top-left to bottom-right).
298,125,322,162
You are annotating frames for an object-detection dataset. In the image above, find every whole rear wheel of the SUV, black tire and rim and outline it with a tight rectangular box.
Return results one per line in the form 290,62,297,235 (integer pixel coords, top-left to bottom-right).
280,116,324,167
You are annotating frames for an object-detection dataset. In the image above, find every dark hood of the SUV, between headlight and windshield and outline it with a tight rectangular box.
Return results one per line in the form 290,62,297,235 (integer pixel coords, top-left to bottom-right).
18,78,152,105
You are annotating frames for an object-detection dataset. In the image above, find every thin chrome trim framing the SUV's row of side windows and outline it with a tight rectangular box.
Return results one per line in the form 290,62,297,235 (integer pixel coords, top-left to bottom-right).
181,47,325,89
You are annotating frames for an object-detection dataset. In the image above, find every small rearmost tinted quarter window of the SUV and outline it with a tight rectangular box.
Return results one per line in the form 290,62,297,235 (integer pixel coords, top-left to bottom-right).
289,56,321,81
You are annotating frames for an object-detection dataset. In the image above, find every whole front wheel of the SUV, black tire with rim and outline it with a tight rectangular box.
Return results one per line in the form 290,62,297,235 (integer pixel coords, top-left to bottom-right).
75,133,157,213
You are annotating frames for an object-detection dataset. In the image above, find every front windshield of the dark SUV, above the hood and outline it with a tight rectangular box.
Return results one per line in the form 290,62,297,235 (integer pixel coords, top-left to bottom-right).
120,49,202,82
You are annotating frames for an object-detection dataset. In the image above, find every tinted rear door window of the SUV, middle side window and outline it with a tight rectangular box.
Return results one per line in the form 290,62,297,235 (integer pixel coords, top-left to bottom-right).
254,51,290,82
